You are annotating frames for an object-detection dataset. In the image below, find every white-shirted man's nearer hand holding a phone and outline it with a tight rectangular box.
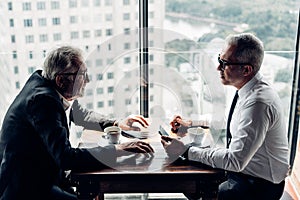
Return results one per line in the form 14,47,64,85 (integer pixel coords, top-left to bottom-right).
161,136,187,158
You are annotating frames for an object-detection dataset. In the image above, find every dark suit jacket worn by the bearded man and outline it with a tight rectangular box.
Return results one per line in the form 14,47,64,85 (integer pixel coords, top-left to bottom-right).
0,70,116,200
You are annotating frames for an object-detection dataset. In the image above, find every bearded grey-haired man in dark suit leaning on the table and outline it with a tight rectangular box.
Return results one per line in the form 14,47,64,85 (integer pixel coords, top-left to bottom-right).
0,46,153,200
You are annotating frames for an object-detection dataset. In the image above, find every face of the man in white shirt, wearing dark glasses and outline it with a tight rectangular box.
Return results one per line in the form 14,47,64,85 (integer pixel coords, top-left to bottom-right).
217,46,243,88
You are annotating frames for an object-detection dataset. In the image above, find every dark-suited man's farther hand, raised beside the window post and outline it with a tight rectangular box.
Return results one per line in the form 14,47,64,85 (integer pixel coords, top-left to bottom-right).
118,115,149,131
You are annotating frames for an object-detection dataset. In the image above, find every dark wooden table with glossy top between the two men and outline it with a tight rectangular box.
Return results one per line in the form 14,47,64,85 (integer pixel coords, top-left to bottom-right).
71,129,224,199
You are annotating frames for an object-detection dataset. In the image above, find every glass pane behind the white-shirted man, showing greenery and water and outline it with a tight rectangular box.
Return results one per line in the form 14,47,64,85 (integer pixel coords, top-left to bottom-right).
149,0,299,145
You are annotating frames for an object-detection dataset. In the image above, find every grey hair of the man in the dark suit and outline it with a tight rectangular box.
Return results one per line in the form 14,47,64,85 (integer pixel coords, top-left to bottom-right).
42,46,83,80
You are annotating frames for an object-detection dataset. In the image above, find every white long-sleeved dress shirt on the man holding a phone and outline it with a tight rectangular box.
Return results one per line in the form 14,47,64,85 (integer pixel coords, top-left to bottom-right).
188,73,289,183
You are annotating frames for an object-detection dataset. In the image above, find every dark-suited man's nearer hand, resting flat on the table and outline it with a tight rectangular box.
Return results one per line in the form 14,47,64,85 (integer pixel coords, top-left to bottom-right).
116,140,154,156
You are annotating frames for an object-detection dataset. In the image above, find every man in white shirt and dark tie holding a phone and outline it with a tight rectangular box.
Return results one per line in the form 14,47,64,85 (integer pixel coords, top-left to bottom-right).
162,33,289,200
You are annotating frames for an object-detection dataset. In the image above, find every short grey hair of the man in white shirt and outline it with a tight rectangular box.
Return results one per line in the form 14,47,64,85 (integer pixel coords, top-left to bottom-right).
225,33,264,73
